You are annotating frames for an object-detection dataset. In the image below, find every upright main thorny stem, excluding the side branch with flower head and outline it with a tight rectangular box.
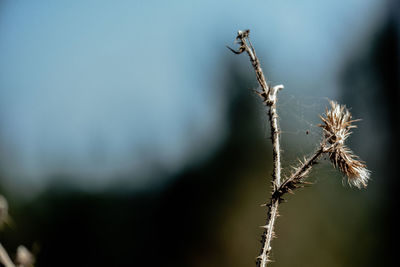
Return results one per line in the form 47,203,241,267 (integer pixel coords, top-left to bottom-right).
228,30,283,267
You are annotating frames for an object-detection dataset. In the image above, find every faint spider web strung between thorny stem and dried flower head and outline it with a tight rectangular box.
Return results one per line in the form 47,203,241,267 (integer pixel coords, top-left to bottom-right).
263,91,337,182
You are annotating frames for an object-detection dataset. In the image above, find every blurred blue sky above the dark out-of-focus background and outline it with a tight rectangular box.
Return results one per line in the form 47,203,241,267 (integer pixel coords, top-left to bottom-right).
0,0,385,193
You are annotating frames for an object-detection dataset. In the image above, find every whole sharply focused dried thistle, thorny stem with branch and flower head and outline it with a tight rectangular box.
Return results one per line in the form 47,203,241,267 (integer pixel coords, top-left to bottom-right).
228,30,370,267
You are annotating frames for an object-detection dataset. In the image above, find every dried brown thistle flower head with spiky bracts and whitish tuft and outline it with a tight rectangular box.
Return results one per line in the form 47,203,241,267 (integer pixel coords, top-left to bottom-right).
319,101,370,188
